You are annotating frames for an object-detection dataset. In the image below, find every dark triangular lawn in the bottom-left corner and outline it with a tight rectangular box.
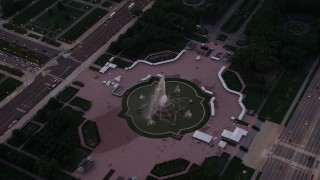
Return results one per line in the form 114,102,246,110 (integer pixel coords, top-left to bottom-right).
0,162,35,180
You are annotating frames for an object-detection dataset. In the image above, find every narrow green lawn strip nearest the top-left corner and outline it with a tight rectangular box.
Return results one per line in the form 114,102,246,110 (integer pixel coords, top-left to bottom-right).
11,0,57,25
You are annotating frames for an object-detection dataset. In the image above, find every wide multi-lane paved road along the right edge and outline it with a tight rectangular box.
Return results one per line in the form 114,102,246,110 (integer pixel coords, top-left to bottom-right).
260,65,320,180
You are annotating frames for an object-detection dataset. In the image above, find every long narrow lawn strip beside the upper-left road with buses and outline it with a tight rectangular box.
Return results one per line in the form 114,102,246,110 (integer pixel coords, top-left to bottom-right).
59,8,108,43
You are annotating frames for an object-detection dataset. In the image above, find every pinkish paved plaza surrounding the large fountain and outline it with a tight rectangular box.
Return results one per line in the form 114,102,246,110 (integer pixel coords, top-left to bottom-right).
70,44,254,179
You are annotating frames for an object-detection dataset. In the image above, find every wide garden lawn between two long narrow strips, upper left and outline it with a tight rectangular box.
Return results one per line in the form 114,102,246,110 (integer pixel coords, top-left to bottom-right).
35,6,85,33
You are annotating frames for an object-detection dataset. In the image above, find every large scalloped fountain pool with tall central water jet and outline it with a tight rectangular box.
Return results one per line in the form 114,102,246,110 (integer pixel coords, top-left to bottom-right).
119,76,210,137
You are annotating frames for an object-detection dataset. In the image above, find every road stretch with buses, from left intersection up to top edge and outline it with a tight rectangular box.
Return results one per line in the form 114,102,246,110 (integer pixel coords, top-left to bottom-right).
71,0,150,61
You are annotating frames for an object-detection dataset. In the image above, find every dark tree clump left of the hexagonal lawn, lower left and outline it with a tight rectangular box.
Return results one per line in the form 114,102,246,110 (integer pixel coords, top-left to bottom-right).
22,107,90,171
